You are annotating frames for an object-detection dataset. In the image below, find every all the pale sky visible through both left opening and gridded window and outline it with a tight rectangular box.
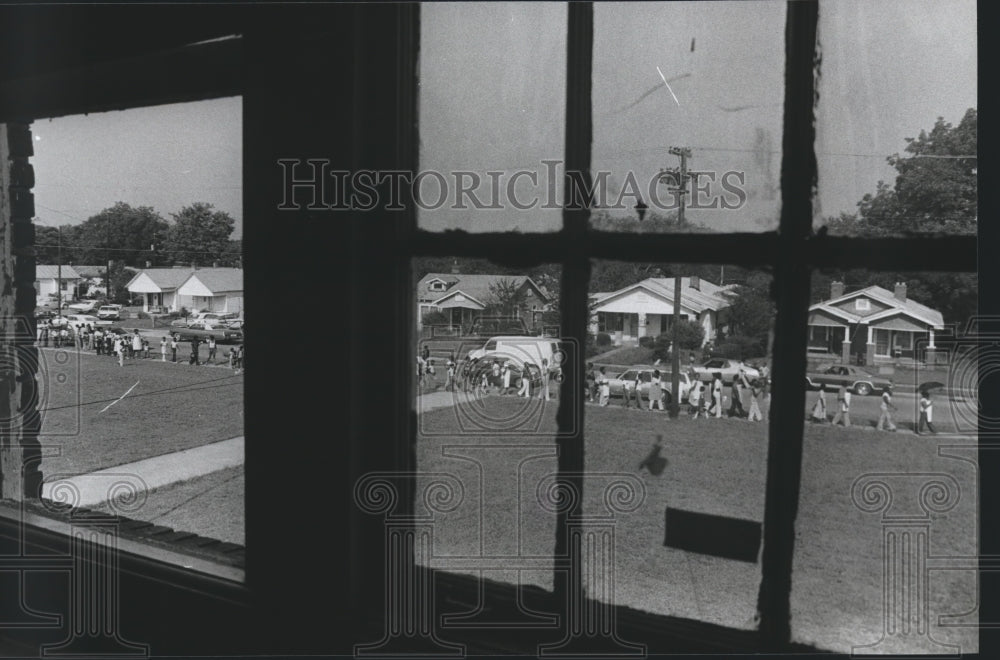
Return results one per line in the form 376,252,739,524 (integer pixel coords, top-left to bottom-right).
33,0,977,236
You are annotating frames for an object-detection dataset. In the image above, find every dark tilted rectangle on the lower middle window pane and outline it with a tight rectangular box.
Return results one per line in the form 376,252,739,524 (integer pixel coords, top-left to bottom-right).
663,507,761,563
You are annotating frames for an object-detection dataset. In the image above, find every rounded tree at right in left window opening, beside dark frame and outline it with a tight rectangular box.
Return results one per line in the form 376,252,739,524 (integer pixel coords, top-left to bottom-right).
164,202,236,265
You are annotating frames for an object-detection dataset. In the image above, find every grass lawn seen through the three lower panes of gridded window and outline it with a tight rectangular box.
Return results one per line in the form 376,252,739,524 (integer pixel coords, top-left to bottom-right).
418,397,978,653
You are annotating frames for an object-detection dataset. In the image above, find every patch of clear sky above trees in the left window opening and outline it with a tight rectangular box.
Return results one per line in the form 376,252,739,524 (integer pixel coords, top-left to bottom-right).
32,97,243,238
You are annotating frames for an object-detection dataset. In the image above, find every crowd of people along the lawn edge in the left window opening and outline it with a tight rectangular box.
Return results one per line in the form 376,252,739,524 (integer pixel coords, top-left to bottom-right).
37,323,245,373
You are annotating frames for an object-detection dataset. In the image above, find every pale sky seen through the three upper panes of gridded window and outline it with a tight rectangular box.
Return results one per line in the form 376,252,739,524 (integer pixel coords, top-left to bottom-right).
419,0,977,231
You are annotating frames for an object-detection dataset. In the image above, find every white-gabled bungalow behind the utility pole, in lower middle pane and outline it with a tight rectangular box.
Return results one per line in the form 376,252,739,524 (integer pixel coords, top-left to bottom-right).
590,277,730,346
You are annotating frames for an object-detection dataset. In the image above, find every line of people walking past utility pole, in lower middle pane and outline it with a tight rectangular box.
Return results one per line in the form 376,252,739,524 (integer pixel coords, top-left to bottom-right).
585,362,770,422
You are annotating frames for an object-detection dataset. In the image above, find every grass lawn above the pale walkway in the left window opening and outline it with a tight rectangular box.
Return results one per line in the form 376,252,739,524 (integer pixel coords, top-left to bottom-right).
39,350,244,479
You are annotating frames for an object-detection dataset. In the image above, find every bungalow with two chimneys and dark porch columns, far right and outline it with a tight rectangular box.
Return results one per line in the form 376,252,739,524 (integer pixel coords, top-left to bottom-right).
808,282,944,364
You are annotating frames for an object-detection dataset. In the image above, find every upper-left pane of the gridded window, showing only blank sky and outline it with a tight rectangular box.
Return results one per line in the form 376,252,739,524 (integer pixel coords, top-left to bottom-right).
415,2,567,232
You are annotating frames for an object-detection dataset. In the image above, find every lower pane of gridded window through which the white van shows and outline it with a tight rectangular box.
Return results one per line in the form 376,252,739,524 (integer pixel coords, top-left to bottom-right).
413,257,565,600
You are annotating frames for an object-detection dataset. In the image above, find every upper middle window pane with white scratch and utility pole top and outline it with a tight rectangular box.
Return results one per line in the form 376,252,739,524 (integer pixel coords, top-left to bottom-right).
591,2,785,232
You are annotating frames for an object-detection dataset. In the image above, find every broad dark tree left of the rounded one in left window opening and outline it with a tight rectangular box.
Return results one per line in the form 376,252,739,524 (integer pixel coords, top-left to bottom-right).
73,202,168,268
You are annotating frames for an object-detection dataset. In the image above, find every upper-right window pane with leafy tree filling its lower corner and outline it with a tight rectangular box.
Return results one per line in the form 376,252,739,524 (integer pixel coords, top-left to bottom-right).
813,0,978,236
